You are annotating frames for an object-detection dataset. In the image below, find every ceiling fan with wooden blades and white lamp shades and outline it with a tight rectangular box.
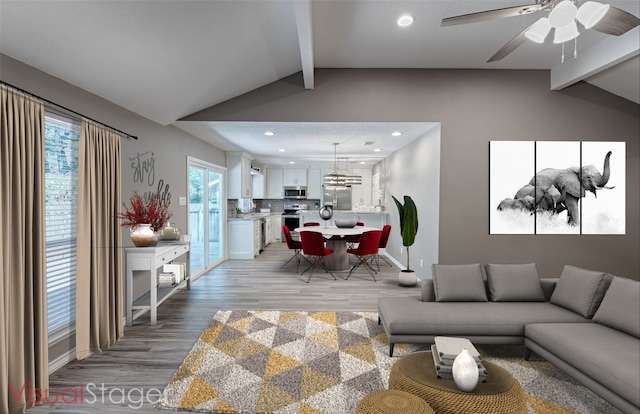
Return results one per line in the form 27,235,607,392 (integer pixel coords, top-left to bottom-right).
440,0,640,63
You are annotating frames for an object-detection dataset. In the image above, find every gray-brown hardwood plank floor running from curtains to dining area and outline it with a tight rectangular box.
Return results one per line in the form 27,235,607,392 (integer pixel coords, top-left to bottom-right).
28,243,420,413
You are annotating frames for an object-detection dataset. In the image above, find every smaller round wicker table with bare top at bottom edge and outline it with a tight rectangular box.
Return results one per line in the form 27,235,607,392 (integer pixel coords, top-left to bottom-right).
356,390,434,414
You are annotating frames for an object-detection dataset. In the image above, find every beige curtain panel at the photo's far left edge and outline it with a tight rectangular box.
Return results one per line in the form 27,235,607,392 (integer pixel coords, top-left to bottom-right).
0,85,49,414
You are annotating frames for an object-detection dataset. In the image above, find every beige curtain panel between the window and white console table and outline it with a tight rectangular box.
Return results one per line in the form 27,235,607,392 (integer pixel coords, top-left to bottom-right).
76,119,124,359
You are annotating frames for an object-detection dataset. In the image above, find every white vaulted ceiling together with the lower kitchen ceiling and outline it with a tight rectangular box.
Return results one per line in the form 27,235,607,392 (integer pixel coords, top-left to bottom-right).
0,0,640,168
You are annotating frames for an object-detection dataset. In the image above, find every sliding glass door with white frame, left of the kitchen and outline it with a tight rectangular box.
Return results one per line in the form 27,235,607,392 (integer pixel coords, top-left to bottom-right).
187,157,226,275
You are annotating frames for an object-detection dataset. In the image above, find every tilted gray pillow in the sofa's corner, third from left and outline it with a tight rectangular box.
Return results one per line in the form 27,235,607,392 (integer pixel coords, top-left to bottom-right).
550,265,610,318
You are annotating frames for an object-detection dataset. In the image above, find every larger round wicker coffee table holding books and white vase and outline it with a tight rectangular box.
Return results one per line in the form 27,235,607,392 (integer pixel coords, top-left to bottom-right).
389,352,527,414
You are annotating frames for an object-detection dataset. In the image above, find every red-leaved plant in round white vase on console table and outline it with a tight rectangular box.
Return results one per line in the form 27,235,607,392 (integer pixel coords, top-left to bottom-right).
115,191,172,247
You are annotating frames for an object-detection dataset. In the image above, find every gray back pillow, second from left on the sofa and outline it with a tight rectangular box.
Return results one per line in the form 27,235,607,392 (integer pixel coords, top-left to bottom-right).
486,263,545,302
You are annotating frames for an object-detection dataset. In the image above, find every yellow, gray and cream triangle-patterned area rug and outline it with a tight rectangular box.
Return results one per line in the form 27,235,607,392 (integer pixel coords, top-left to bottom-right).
156,311,617,414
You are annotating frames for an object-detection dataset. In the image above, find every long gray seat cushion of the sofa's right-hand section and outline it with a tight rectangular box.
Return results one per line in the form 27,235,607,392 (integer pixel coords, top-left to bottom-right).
525,323,640,407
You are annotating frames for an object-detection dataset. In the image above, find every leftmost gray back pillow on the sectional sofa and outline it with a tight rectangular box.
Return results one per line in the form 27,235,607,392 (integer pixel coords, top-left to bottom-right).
432,263,487,302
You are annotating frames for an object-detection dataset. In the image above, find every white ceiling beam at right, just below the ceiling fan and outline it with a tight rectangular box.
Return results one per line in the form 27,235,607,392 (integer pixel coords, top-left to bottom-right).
551,26,640,91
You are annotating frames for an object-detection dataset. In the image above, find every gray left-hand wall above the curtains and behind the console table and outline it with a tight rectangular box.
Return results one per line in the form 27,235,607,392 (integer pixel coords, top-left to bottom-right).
0,55,227,246
